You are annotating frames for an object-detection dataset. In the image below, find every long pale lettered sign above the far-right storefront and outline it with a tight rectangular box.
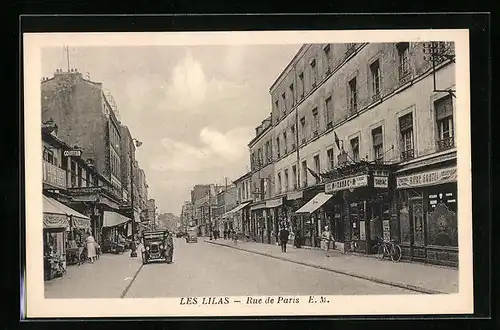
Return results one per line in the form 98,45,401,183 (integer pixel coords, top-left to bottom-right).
396,167,457,189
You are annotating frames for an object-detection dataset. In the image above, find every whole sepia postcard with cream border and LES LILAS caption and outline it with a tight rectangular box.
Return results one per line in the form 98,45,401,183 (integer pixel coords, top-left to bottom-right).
23,30,473,318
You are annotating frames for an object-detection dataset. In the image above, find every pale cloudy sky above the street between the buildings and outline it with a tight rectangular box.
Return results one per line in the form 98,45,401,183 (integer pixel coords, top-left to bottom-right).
42,44,301,215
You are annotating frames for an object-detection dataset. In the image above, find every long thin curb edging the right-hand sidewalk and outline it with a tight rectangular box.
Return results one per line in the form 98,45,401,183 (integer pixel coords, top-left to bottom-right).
205,241,448,294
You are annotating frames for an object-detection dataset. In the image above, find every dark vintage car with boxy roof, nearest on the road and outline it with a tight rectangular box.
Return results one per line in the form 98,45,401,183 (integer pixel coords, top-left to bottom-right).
142,230,173,264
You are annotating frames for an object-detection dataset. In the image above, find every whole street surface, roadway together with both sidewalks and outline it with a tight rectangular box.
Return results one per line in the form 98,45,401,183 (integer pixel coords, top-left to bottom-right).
45,238,458,298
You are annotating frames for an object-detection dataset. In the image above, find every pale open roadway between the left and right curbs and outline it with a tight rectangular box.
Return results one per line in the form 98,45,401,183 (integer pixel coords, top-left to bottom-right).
125,239,415,298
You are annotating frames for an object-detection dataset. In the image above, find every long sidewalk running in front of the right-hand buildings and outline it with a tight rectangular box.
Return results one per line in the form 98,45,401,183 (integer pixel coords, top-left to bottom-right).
205,239,458,294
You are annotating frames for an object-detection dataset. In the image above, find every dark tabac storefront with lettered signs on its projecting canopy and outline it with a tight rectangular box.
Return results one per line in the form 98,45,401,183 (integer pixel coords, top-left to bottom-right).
325,162,397,254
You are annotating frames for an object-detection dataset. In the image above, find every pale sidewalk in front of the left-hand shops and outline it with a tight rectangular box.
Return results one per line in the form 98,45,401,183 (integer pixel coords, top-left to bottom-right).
45,250,142,299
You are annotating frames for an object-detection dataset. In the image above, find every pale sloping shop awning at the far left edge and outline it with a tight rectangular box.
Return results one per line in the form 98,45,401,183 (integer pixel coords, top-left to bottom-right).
43,196,83,229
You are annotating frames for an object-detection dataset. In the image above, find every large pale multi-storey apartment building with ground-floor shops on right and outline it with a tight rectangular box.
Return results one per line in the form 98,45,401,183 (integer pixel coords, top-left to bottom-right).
269,42,458,265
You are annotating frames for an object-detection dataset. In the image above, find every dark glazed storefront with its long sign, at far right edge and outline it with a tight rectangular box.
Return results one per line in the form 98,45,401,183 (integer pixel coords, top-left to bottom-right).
396,161,458,266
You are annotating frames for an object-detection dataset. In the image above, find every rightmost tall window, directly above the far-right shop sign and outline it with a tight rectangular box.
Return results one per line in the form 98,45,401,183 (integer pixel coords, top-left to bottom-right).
434,95,455,151
